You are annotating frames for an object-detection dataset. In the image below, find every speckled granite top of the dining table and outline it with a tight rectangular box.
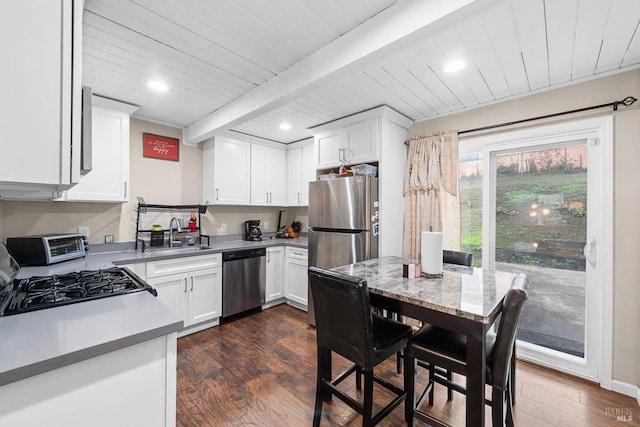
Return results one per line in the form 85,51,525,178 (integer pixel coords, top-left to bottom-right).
331,257,515,323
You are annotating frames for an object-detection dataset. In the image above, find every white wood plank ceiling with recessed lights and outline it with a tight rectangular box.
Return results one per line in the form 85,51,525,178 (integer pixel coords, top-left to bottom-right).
83,0,640,143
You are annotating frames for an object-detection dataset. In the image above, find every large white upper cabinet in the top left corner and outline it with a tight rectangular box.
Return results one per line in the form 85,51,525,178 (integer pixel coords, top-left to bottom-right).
0,0,82,198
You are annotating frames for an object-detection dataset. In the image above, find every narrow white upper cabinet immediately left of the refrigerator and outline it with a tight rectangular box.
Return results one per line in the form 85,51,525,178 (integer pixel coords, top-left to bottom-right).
286,141,316,206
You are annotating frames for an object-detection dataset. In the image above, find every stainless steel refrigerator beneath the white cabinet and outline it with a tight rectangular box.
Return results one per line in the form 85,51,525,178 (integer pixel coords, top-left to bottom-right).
308,175,378,325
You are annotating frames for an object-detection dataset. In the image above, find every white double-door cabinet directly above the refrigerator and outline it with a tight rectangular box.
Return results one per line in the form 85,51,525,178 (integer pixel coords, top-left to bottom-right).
315,119,378,169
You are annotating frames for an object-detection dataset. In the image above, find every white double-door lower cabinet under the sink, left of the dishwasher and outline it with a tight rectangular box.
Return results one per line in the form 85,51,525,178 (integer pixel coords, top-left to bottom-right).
146,254,222,336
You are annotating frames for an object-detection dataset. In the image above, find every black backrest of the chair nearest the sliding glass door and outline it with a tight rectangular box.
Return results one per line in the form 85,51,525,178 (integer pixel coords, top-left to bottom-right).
487,273,530,390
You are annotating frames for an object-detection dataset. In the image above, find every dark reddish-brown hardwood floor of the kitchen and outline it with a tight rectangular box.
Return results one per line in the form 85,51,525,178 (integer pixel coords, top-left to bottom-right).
177,305,640,427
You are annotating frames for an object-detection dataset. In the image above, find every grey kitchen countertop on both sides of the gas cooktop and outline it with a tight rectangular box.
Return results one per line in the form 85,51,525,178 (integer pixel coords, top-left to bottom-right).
0,237,307,386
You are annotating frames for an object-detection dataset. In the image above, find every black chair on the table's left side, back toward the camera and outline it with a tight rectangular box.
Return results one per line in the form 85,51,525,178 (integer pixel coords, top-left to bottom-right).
309,267,413,426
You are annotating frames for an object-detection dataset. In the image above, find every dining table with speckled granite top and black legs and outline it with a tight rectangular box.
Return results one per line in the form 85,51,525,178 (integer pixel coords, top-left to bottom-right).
330,256,517,426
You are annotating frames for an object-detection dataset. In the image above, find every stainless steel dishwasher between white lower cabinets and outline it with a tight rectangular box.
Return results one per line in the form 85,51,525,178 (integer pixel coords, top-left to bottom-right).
222,248,267,318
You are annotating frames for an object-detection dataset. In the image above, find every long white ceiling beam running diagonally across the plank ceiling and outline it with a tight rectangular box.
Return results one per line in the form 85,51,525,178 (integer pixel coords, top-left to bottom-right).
183,0,501,144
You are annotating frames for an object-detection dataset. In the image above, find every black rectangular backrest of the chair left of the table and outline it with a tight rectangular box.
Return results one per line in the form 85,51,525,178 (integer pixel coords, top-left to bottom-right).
309,267,373,369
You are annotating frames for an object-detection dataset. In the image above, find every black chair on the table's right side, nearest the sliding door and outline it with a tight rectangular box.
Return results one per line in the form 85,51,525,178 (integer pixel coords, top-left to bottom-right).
404,274,529,426
